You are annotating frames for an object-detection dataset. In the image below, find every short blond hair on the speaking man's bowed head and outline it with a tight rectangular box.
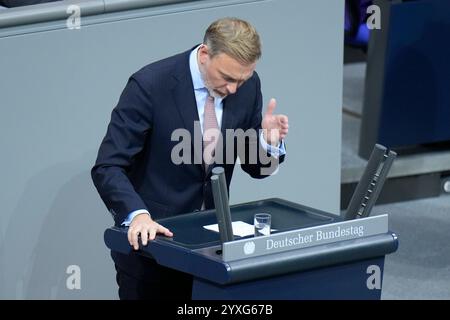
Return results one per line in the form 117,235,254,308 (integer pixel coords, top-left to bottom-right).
203,18,261,64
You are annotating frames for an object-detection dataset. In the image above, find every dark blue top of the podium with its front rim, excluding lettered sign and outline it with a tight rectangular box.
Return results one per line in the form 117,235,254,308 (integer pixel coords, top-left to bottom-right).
104,198,398,284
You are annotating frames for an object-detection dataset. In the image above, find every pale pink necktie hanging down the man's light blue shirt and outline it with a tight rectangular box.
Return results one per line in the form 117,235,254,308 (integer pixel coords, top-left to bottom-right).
203,95,220,170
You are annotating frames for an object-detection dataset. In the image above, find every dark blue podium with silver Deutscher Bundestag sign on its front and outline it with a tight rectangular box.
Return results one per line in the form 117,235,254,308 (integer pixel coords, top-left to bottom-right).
104,198,398,300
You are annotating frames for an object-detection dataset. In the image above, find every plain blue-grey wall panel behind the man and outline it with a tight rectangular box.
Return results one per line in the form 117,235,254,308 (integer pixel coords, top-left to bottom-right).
0,0,344,299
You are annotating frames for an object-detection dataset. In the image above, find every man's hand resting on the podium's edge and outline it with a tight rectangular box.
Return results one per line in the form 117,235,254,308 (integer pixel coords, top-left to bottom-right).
128,213,173,250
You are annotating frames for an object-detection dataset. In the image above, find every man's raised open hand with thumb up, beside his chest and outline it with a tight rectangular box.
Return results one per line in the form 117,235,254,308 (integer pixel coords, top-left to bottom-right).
261,98,289,146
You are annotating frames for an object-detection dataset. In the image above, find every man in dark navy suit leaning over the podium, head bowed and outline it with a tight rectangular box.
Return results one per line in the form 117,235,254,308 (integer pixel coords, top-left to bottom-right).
92,18,288,299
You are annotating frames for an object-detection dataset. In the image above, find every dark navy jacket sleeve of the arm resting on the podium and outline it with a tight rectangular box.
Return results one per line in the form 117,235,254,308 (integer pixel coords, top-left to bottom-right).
91,77,152,225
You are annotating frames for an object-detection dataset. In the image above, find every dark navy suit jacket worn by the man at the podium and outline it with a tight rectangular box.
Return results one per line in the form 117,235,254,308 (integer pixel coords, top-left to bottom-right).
91,49,284,278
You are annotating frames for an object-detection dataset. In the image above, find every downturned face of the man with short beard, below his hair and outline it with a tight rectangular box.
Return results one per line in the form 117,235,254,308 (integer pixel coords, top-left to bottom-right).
198,45,256,98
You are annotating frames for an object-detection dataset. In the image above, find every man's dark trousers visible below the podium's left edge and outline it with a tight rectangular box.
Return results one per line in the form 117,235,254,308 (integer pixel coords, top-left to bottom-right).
115,259,192,301
